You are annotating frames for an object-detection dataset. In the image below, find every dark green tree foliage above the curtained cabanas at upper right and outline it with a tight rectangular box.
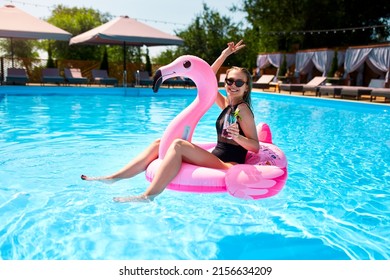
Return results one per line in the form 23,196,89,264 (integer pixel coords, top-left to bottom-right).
242,0,390,52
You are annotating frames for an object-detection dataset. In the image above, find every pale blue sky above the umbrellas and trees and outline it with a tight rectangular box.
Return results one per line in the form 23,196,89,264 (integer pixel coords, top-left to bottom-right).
0,0,245,57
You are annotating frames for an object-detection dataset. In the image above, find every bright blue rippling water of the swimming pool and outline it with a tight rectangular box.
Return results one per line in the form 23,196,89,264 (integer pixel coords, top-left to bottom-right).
0,88,390,260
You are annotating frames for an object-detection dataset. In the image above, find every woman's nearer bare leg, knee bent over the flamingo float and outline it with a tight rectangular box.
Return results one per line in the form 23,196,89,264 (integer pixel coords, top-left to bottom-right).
114,139,232,202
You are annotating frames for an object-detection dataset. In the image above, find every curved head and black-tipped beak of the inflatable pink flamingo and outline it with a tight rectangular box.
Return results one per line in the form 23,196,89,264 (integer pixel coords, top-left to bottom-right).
153,55,218,92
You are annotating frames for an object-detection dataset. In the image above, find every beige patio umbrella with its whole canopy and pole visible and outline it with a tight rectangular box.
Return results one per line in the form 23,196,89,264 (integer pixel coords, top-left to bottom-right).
69,16,183,85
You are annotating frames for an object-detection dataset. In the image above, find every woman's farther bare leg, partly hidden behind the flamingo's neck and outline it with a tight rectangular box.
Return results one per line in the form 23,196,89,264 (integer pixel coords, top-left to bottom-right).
81,139,160,183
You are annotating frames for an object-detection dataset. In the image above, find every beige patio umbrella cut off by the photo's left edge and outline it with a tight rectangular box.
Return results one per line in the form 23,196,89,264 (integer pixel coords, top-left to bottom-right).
0,5,72,66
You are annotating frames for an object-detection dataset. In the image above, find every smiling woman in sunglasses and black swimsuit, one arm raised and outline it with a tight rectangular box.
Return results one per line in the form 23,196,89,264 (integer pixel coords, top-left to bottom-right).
81,40,259,202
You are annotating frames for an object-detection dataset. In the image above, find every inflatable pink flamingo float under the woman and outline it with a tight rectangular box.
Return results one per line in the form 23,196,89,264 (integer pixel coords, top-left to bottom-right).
146,55,287,199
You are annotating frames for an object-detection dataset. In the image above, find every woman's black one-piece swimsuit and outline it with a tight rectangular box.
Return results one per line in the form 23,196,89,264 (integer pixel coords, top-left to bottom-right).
212,102,249,163
